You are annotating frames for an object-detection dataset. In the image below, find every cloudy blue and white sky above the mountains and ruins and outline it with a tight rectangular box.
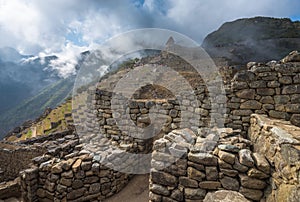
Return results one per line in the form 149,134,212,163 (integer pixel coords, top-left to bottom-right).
0,0,300,76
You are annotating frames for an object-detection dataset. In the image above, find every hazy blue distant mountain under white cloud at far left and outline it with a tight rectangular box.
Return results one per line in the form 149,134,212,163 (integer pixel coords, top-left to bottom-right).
0,48,60,113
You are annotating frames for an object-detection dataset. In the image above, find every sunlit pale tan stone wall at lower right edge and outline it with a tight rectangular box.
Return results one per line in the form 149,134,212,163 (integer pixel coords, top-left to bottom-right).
248,114,300,202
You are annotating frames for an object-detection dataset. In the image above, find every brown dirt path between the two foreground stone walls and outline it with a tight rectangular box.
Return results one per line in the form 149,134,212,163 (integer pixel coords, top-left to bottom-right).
105,175,149,202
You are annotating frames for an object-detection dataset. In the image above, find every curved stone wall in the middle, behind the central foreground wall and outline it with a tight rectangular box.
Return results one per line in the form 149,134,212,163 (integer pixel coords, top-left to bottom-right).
95,89,211,153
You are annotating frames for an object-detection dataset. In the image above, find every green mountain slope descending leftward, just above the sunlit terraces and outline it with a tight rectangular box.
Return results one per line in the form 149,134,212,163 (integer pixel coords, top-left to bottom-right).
0,77,75,139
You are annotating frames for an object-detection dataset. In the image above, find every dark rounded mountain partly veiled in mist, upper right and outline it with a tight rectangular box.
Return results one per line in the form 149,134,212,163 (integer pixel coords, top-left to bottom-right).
202,17,300,64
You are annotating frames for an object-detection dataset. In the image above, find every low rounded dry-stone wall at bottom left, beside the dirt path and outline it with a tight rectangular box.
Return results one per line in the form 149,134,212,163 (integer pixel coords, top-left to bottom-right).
21,152,130,202
